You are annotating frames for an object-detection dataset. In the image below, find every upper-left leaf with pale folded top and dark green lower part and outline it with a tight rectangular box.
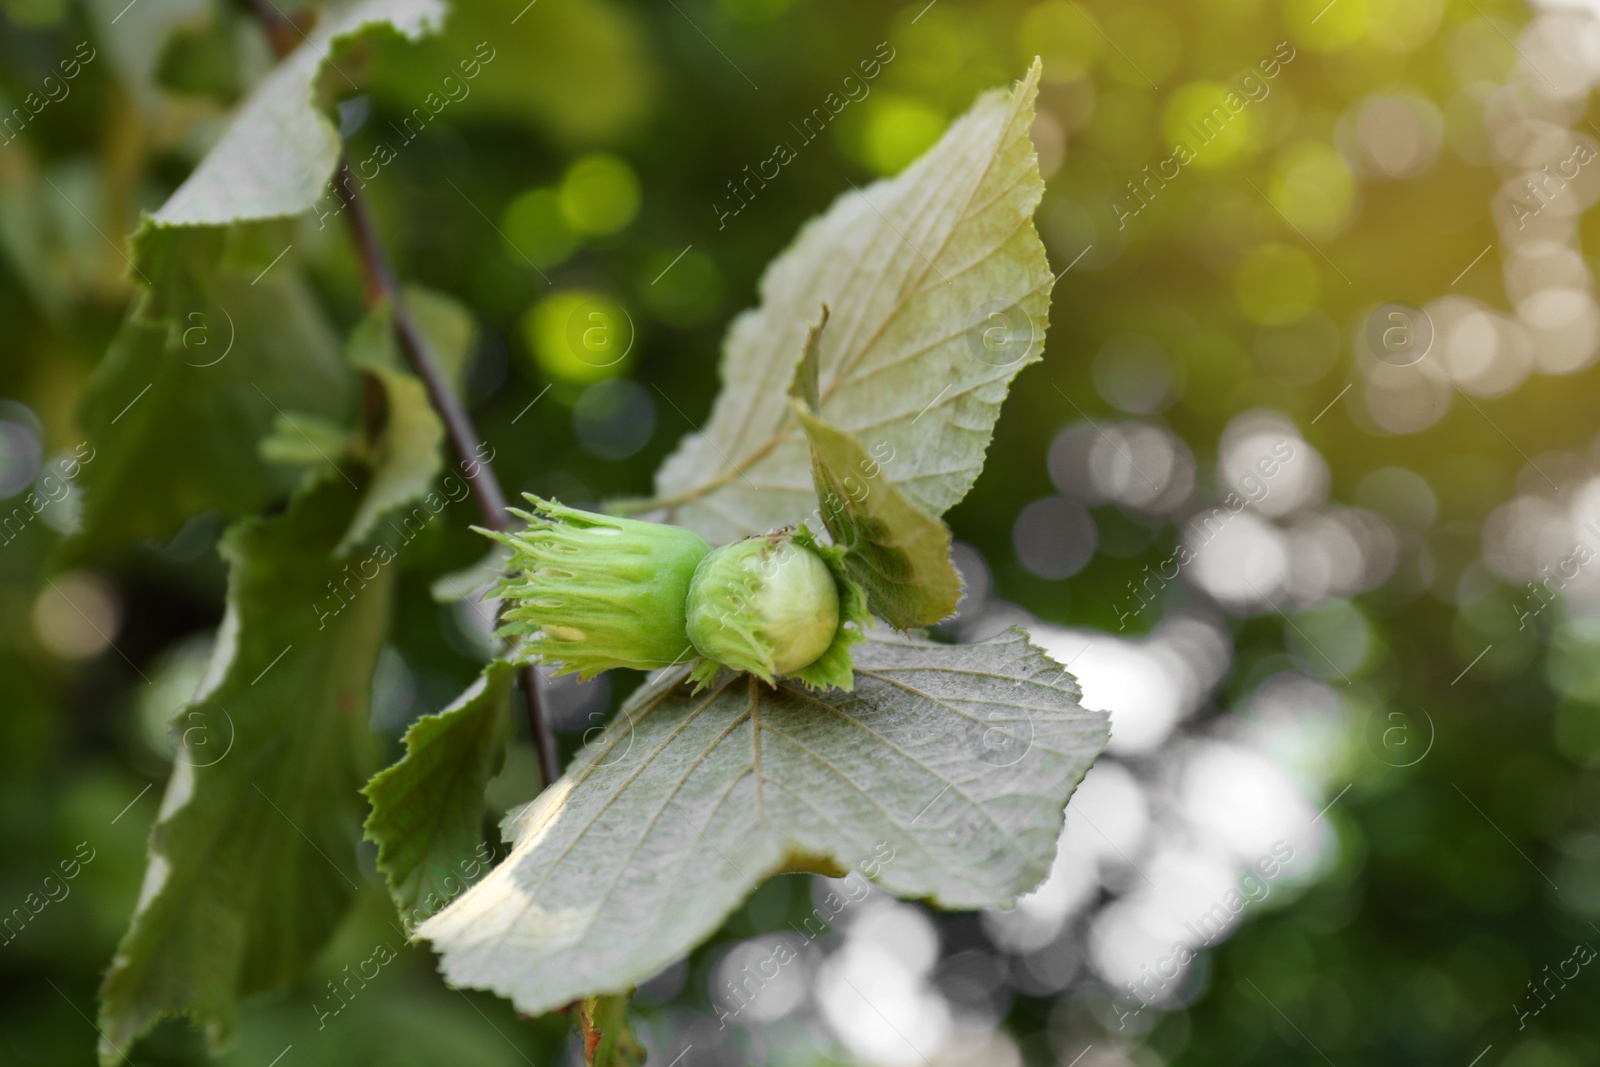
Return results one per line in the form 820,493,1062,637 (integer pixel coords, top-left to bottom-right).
66,0,445,560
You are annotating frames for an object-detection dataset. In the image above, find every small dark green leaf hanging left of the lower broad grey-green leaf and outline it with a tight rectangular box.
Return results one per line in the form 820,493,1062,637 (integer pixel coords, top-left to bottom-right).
362,661,514,929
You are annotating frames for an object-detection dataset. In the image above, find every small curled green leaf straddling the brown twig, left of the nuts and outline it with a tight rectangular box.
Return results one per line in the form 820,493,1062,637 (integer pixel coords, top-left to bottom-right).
339,290,474,553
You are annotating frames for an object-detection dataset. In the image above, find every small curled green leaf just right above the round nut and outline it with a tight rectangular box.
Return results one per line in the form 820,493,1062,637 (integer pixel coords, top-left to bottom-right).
792,400,962,630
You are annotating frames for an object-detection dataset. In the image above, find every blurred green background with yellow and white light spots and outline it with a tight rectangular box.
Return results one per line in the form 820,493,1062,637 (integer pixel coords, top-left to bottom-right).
0,0,1600,1067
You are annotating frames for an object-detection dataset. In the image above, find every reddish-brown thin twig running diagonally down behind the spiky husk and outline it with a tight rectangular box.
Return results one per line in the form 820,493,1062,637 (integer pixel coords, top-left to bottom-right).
245,0,562,785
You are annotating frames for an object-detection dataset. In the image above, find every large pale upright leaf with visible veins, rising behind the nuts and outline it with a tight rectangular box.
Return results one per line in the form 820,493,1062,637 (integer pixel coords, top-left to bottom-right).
630,64,1051,542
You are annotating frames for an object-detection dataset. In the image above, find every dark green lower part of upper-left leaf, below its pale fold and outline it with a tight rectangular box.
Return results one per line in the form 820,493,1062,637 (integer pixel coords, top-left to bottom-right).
67,270,349,558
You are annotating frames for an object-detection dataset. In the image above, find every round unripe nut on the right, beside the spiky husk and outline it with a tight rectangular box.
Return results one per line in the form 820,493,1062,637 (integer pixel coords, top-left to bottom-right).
688,534,838,681
